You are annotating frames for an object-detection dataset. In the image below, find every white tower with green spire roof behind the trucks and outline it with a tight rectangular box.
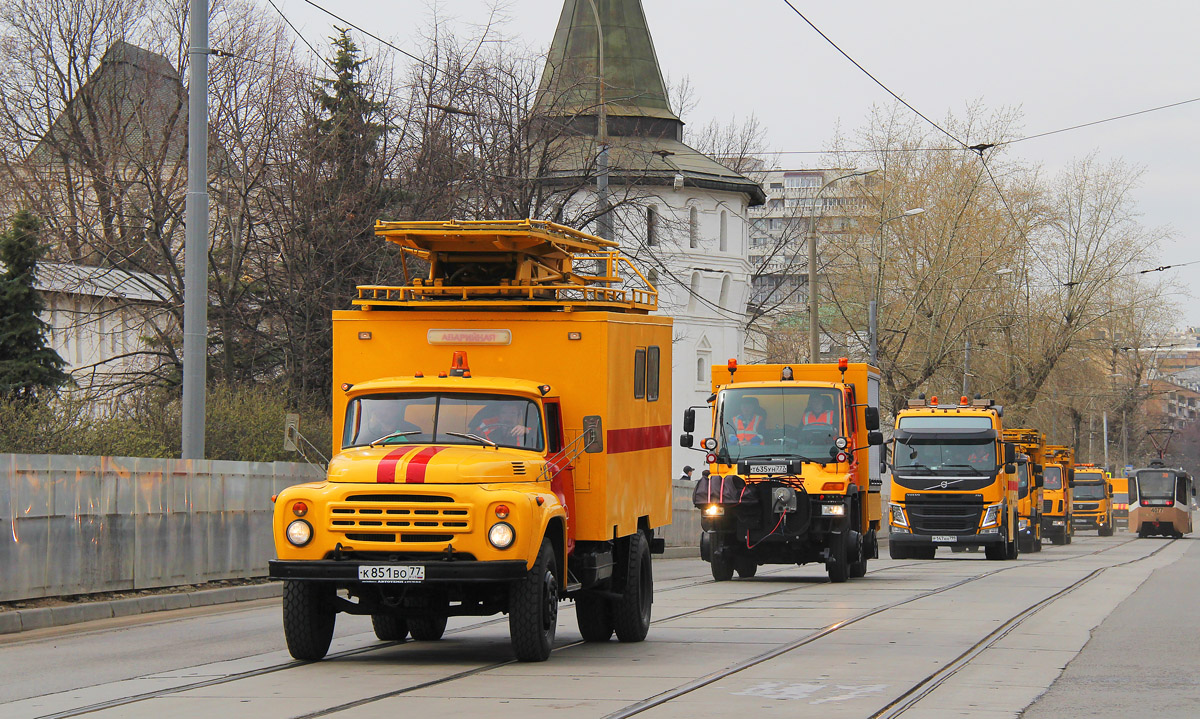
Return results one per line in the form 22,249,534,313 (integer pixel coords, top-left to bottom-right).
535,0,766,484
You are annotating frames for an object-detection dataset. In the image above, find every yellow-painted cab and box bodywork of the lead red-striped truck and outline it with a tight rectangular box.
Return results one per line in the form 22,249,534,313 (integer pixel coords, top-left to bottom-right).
275,307,672,574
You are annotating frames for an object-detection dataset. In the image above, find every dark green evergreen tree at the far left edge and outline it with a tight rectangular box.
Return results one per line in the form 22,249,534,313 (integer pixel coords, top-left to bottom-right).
0,210,70,402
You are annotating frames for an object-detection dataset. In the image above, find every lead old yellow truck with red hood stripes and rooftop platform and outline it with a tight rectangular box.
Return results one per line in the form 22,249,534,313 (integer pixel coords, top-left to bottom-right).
270,221,672,661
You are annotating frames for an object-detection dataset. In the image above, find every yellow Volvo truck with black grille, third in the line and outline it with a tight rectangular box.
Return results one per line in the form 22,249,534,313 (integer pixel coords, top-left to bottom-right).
888,395,1028,559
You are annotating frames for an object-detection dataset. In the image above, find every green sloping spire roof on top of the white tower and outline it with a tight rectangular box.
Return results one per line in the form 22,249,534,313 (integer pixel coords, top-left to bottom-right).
538,0,679,120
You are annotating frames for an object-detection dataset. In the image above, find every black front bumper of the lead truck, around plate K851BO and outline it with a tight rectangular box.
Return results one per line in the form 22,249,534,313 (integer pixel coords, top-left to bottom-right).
268,559,527,586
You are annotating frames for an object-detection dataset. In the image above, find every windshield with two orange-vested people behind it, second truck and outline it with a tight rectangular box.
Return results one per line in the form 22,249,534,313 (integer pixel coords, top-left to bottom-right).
716,387,841,463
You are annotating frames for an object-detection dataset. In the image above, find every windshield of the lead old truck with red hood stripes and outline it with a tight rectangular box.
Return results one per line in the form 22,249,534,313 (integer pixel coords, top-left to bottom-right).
342,393,544,451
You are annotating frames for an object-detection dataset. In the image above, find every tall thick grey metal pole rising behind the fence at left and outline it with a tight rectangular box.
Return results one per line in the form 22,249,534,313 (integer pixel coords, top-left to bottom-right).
180,0,209,460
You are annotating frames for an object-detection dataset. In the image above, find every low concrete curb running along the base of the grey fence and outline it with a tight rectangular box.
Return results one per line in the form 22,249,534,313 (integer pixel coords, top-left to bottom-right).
0,582,283,634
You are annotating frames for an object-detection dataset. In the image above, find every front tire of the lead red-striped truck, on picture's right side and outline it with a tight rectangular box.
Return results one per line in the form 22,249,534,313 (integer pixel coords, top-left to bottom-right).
509,539,559,661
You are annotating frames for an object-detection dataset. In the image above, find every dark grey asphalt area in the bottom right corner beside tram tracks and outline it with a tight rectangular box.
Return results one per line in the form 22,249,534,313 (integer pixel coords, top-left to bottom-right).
1022,537,1200,719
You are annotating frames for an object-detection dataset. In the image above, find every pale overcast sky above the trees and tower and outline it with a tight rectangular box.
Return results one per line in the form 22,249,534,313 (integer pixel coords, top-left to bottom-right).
274,0,1200,325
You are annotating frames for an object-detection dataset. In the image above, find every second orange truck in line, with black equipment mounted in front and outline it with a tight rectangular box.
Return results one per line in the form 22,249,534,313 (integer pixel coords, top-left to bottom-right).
680,358,883,582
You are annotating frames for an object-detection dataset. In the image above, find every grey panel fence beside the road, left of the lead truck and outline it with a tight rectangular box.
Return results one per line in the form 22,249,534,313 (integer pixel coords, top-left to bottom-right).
0,455,323,601
